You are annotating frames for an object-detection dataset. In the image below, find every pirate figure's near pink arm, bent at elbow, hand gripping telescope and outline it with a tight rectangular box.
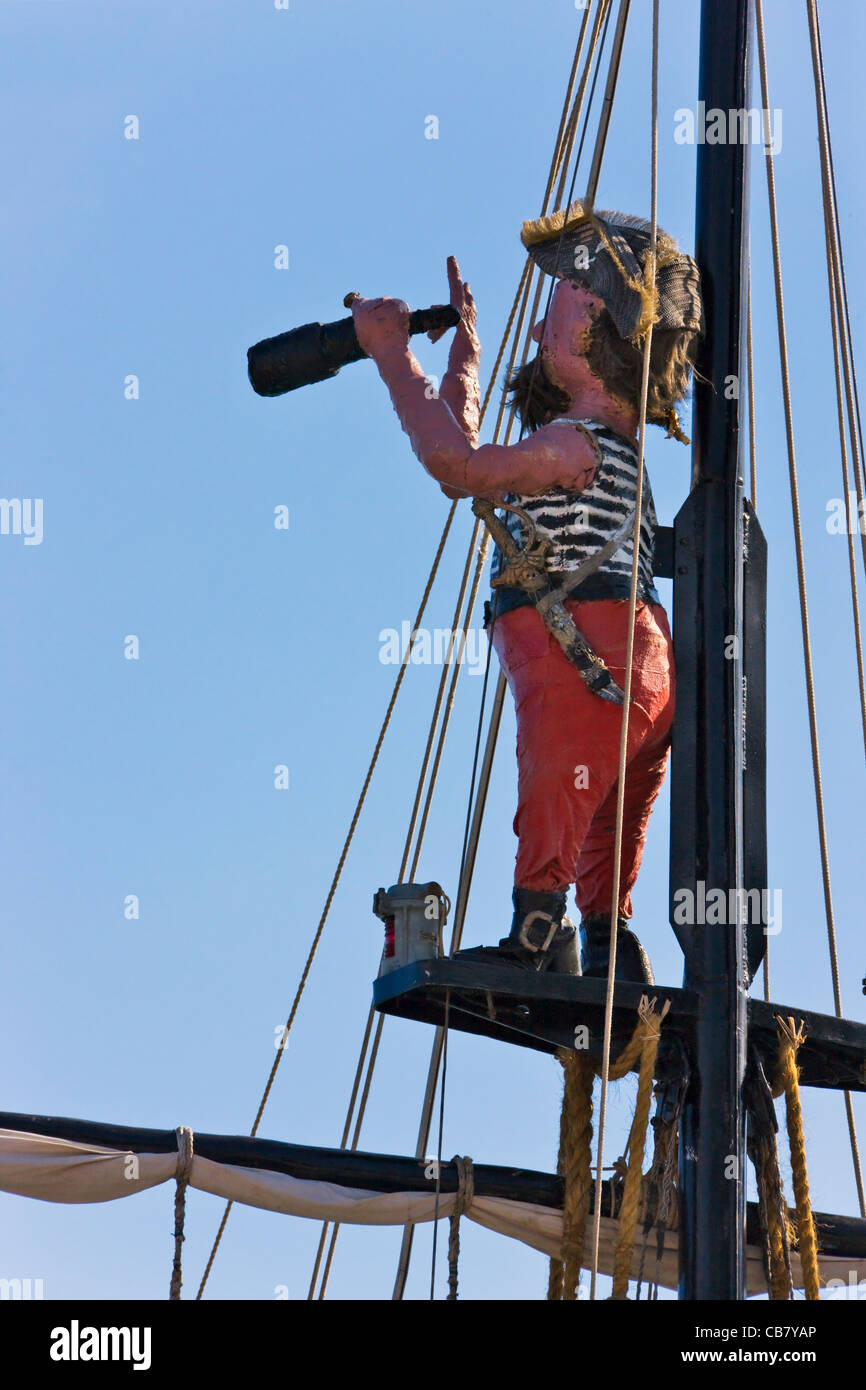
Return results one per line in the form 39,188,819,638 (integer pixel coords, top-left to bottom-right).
352,300,598,500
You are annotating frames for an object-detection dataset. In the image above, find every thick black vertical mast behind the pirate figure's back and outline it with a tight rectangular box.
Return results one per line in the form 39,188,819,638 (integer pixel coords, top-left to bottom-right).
671,0,766,1300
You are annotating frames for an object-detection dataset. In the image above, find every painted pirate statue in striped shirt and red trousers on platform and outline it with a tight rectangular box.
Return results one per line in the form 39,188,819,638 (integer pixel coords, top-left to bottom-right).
352,203,702,984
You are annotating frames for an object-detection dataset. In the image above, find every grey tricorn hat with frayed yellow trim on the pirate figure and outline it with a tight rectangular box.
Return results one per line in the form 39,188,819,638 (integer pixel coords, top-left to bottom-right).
520,203,703,342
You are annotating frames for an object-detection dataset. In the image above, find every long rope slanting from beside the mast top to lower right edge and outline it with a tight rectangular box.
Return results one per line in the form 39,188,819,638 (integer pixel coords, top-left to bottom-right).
755,0,866,1216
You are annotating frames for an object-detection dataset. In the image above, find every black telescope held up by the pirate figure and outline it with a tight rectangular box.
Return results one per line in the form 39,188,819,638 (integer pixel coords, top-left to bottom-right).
246,293,460,396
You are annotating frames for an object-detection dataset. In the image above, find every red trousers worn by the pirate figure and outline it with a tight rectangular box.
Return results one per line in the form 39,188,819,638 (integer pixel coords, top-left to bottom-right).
492,599,674,917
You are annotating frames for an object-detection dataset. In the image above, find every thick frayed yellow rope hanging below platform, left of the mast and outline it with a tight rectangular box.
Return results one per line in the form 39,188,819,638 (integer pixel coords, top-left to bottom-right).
548,995,670,1302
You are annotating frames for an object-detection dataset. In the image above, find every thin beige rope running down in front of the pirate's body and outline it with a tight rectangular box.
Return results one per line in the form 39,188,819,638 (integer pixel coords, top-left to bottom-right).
589,0,659,1298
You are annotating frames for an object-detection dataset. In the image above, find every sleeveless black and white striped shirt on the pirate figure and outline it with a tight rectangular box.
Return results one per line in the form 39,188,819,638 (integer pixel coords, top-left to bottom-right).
492,418,659,613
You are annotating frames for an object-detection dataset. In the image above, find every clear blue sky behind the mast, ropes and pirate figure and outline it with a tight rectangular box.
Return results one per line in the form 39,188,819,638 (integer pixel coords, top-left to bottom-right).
0,0,866,1300
